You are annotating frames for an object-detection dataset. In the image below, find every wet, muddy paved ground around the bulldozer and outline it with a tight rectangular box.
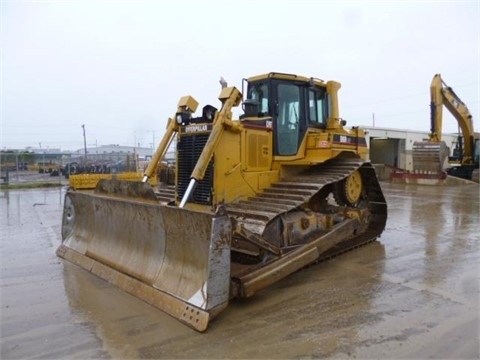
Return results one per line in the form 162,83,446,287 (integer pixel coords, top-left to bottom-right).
0,183,480,359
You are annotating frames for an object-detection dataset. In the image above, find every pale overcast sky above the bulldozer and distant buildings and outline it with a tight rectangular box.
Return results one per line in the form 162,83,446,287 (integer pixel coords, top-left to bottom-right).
0,0,480,150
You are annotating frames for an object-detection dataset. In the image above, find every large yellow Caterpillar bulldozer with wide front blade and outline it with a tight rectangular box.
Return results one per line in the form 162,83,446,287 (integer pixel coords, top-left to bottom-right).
57,73,387,331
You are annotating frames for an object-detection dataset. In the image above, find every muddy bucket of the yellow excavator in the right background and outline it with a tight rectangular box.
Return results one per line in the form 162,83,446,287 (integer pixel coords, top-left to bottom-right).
412,141,449,173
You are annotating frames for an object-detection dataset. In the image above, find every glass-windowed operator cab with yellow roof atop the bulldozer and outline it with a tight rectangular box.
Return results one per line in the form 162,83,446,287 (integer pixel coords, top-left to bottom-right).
241,73,329,156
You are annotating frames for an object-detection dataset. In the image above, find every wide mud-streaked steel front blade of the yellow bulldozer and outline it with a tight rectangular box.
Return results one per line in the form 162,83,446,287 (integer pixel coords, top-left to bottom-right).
57,184,231,331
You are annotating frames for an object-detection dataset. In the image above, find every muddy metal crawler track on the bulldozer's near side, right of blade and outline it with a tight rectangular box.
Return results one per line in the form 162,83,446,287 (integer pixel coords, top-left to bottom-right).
227,158,387,290
